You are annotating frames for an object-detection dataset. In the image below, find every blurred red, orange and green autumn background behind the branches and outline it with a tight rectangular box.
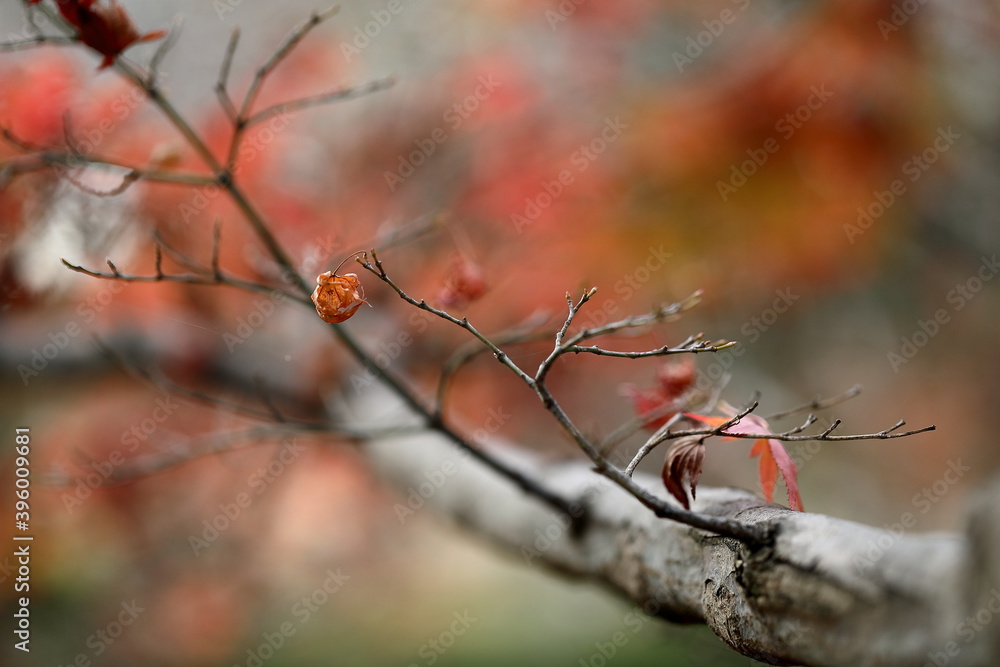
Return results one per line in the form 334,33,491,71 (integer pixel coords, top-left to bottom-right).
0,0,1000,665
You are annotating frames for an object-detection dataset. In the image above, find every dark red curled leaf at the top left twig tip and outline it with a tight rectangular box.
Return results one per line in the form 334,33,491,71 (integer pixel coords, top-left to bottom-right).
28,0,167,69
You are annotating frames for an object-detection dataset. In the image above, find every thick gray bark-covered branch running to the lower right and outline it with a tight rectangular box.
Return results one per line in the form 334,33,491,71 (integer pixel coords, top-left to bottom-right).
352,388,1000,666
